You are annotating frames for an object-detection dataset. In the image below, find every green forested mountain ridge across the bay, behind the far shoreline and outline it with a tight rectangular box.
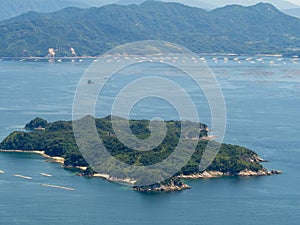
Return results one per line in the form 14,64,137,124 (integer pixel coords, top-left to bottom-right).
0,1,300,57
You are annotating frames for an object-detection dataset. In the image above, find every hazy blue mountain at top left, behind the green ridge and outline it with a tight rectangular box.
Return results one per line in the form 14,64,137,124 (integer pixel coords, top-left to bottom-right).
0,0,88,20
